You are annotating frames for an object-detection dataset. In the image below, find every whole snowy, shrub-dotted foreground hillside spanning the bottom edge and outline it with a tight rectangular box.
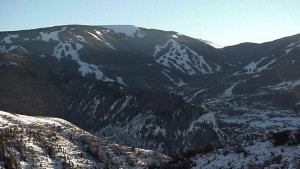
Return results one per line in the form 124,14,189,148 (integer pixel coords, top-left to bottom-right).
0,111,300,169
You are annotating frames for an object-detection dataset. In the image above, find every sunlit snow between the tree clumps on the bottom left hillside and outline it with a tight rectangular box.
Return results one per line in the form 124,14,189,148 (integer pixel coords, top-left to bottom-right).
0,111,170,169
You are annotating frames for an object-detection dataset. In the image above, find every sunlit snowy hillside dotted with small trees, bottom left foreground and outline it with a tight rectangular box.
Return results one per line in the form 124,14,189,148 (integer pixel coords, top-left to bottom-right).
0,111,170,169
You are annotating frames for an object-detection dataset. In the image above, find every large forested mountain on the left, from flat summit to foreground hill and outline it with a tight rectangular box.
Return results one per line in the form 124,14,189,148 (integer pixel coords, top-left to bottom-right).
0,26,223,154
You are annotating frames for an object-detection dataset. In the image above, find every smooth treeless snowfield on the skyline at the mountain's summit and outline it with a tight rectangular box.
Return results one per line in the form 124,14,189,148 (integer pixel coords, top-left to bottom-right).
102,25,145,38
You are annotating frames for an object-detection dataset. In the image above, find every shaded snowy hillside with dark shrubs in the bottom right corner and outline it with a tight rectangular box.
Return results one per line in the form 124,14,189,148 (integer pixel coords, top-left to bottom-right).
192,130,300,169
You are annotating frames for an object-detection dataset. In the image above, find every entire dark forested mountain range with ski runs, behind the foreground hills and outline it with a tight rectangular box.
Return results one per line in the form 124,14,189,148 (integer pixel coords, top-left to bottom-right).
0,25,300,166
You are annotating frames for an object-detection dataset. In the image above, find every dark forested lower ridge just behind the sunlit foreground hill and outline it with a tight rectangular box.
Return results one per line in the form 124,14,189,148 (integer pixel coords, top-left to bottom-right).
0,51,217,154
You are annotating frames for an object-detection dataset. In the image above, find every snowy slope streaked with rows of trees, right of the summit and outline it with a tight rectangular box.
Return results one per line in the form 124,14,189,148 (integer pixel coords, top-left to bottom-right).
153,39,213,75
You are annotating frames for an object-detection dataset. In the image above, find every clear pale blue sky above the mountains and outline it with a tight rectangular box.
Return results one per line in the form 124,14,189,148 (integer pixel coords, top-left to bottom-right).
0,0,300,46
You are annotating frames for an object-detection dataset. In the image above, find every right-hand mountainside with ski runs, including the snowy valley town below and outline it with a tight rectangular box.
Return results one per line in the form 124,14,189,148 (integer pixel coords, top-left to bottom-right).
174,34,300,154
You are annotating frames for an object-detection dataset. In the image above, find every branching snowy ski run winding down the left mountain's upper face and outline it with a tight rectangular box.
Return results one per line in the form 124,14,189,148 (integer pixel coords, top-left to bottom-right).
52,42,114,82
